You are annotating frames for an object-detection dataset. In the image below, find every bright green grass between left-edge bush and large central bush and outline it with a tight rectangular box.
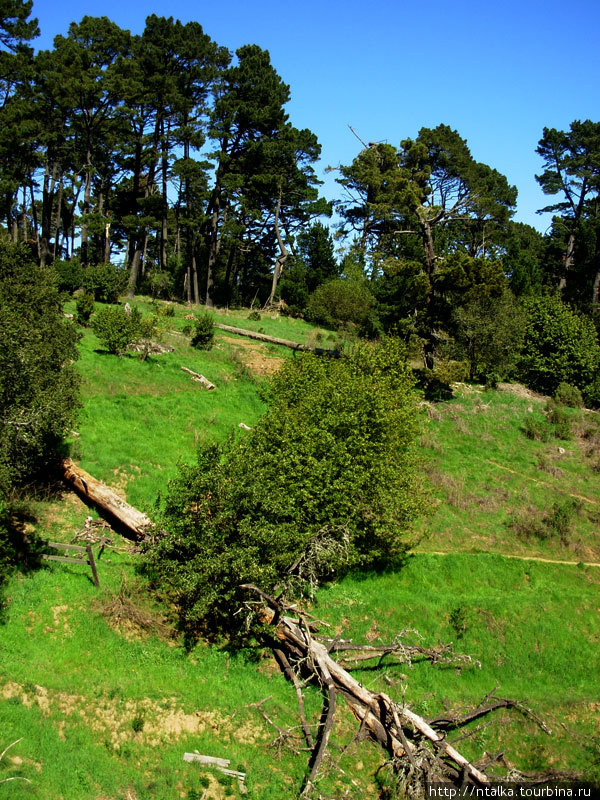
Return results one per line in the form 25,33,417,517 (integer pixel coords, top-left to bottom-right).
72,322,263,511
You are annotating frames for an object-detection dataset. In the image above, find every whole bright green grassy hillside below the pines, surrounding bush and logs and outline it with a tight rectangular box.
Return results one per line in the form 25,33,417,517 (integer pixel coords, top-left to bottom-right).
0,307,600,800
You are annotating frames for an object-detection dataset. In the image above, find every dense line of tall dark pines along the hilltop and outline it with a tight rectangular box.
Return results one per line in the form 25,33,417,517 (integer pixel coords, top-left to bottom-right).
0,0,600,402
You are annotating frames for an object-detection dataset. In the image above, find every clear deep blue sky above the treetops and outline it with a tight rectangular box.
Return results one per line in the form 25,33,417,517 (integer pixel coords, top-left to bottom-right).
33,0,600,231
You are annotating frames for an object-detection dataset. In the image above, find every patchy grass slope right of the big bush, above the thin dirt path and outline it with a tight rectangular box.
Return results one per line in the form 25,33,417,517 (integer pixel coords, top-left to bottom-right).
420,387,600,561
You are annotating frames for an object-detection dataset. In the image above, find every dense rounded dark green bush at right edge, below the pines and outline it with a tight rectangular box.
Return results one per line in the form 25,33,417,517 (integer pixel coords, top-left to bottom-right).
518,295,600,395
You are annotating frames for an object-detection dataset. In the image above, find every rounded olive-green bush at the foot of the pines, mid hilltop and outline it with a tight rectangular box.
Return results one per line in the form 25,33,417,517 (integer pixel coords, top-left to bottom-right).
307,278,373,328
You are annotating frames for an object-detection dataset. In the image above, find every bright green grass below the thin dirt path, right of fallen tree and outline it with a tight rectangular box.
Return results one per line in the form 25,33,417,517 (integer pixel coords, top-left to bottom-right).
314,554,600,779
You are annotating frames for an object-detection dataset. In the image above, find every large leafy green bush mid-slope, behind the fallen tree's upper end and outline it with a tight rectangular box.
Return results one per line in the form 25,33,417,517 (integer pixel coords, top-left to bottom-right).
148,340,422,631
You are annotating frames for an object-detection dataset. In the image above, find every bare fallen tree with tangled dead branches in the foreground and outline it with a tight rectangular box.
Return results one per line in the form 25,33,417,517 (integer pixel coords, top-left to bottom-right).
241,584,550,796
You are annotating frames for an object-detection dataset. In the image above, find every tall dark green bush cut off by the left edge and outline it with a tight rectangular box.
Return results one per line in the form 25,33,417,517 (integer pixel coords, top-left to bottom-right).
0,243,79,495
